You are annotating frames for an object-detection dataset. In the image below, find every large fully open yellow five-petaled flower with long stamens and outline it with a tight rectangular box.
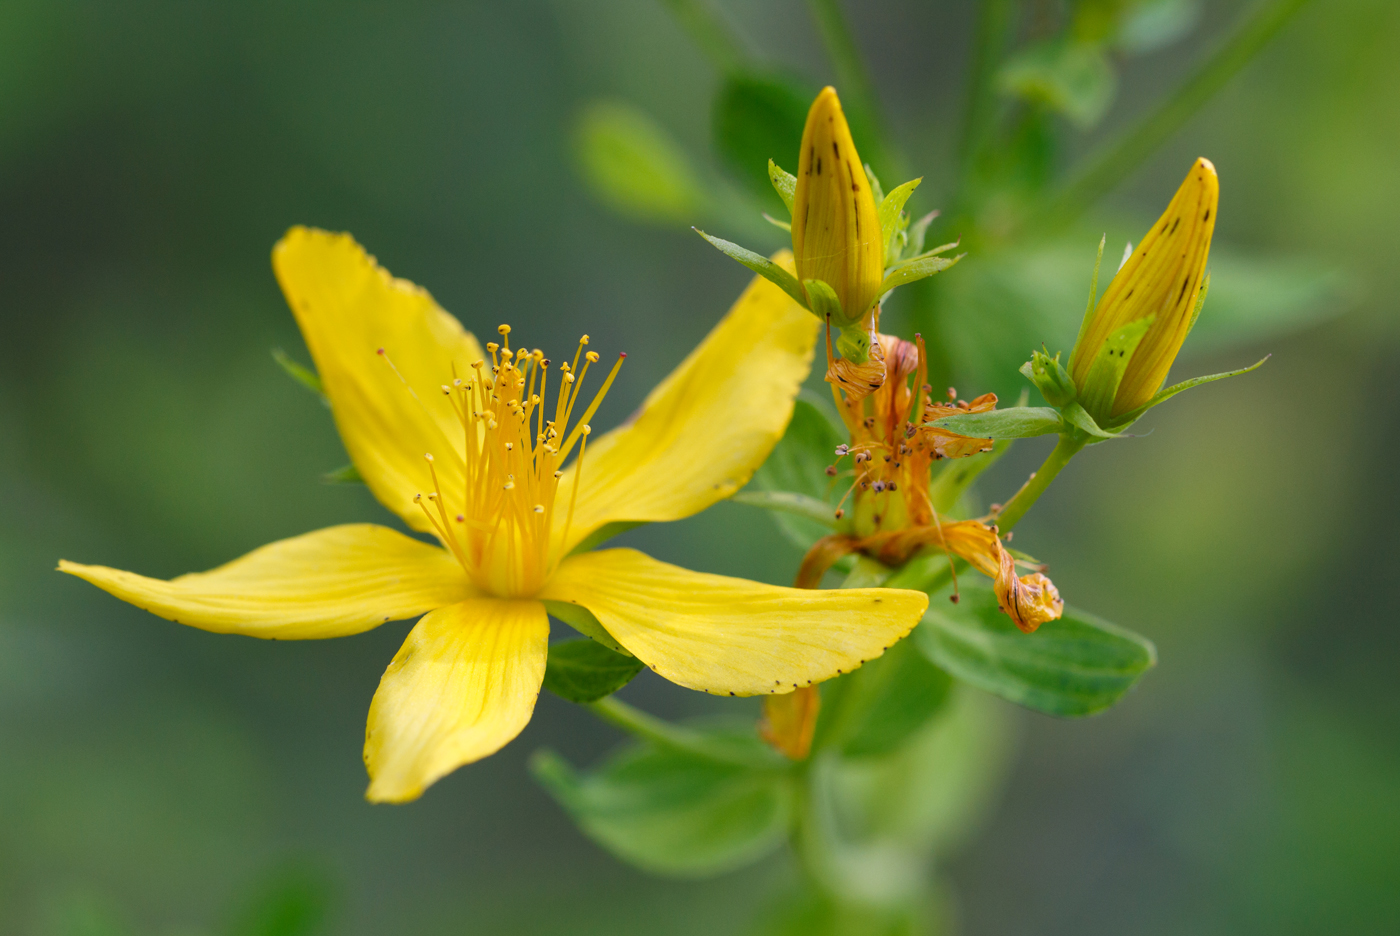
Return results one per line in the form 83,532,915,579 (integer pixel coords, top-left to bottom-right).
59,228,927,802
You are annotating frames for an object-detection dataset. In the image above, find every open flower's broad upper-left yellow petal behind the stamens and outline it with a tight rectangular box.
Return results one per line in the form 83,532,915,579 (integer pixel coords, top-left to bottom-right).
272,227,483,532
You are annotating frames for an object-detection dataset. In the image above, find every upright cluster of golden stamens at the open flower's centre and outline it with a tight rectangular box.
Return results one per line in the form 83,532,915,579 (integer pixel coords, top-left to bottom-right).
400,325,627,597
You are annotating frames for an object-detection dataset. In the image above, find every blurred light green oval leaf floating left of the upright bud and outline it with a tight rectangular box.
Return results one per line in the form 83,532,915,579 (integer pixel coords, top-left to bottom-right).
574,101,706,224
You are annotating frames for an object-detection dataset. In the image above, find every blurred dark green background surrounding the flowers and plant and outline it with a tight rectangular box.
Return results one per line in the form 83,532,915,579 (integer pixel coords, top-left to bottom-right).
0,0,1400,936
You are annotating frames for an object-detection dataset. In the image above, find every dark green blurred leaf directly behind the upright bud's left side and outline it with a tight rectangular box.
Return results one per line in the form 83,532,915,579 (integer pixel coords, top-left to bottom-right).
713,71,816,211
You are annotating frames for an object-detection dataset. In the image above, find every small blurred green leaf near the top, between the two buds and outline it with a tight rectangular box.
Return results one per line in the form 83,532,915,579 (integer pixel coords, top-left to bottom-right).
997,39,1117,127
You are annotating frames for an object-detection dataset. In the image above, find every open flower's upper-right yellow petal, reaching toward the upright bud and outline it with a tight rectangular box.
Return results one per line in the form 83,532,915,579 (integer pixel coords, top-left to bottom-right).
554,256,819,551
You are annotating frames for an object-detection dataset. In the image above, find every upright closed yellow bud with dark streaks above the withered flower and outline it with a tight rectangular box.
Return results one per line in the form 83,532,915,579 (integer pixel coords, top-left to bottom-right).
792,87,885,327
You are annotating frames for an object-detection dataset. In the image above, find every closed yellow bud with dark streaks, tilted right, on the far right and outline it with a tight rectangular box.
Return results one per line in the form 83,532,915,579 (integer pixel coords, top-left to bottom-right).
1070,159,1219,424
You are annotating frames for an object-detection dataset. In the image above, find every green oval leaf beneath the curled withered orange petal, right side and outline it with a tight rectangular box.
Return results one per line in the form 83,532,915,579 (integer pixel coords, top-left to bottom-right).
914,582,1156,716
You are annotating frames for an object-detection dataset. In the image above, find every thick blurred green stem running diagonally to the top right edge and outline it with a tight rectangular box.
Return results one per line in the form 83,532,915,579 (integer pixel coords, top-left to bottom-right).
1037,0,1308,225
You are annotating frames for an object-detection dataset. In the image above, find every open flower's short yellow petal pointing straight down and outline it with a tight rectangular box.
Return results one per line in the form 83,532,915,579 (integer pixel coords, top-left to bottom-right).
364,597,549,803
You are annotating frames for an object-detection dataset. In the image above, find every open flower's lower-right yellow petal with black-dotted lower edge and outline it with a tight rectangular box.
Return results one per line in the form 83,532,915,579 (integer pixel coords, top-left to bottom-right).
540,550,928,695
